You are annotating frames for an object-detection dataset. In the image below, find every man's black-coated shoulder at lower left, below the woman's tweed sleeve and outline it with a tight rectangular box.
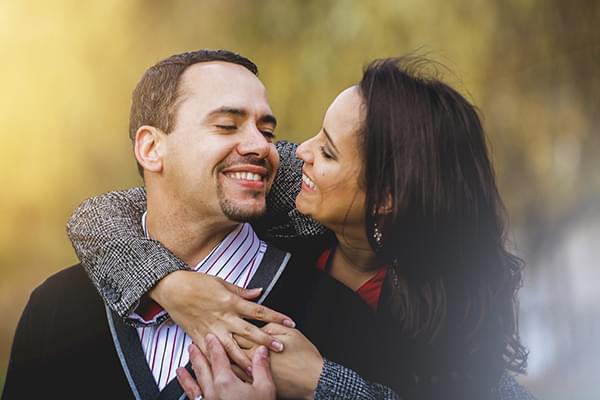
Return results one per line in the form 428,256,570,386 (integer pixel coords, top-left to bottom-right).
5,265,130,399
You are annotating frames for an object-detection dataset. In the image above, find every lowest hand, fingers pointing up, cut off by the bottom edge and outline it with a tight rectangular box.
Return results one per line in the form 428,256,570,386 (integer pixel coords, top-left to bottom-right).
177,335,275,400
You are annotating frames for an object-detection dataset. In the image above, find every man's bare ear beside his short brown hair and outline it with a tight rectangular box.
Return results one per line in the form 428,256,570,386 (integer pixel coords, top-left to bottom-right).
133,125,166,173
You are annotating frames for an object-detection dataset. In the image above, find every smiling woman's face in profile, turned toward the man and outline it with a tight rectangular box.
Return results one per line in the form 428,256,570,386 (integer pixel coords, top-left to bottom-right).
296,86,365,232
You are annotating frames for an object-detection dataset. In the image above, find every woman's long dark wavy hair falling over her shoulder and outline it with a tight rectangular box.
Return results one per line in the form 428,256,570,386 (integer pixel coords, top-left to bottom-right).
359,56,527,372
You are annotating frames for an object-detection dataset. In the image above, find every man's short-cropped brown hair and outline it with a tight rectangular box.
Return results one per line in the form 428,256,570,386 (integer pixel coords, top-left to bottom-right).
129,49,258,177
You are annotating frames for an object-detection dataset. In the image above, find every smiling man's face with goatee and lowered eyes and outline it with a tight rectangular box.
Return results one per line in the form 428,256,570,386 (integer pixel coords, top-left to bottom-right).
163,62,279,221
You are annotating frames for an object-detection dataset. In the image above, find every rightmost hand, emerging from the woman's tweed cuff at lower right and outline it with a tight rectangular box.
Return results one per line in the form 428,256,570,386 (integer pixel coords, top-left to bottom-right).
234,323,324,399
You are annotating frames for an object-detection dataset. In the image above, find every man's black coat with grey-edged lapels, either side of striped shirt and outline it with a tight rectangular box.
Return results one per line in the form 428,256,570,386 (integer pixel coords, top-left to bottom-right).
2,239,390,400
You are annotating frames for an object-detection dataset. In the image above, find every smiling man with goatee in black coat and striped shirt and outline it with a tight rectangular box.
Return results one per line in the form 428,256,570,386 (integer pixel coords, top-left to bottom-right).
3,50,290,399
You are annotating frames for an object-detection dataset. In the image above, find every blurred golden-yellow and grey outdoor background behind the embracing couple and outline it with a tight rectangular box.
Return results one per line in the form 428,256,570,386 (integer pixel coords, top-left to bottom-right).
0,0,600,399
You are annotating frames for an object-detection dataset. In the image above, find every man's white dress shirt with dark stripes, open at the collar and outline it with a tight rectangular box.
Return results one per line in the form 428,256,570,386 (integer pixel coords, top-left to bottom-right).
135,213,267,390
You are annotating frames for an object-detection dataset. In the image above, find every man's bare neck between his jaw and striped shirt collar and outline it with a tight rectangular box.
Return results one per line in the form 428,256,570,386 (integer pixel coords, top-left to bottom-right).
146,198,239,267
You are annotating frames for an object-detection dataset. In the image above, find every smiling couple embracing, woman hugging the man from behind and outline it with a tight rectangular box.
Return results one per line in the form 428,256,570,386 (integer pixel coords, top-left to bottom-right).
5,51,529,399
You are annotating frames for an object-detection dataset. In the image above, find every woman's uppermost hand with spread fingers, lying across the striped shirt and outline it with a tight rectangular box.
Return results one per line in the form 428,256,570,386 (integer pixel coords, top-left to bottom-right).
150,271,295,371
